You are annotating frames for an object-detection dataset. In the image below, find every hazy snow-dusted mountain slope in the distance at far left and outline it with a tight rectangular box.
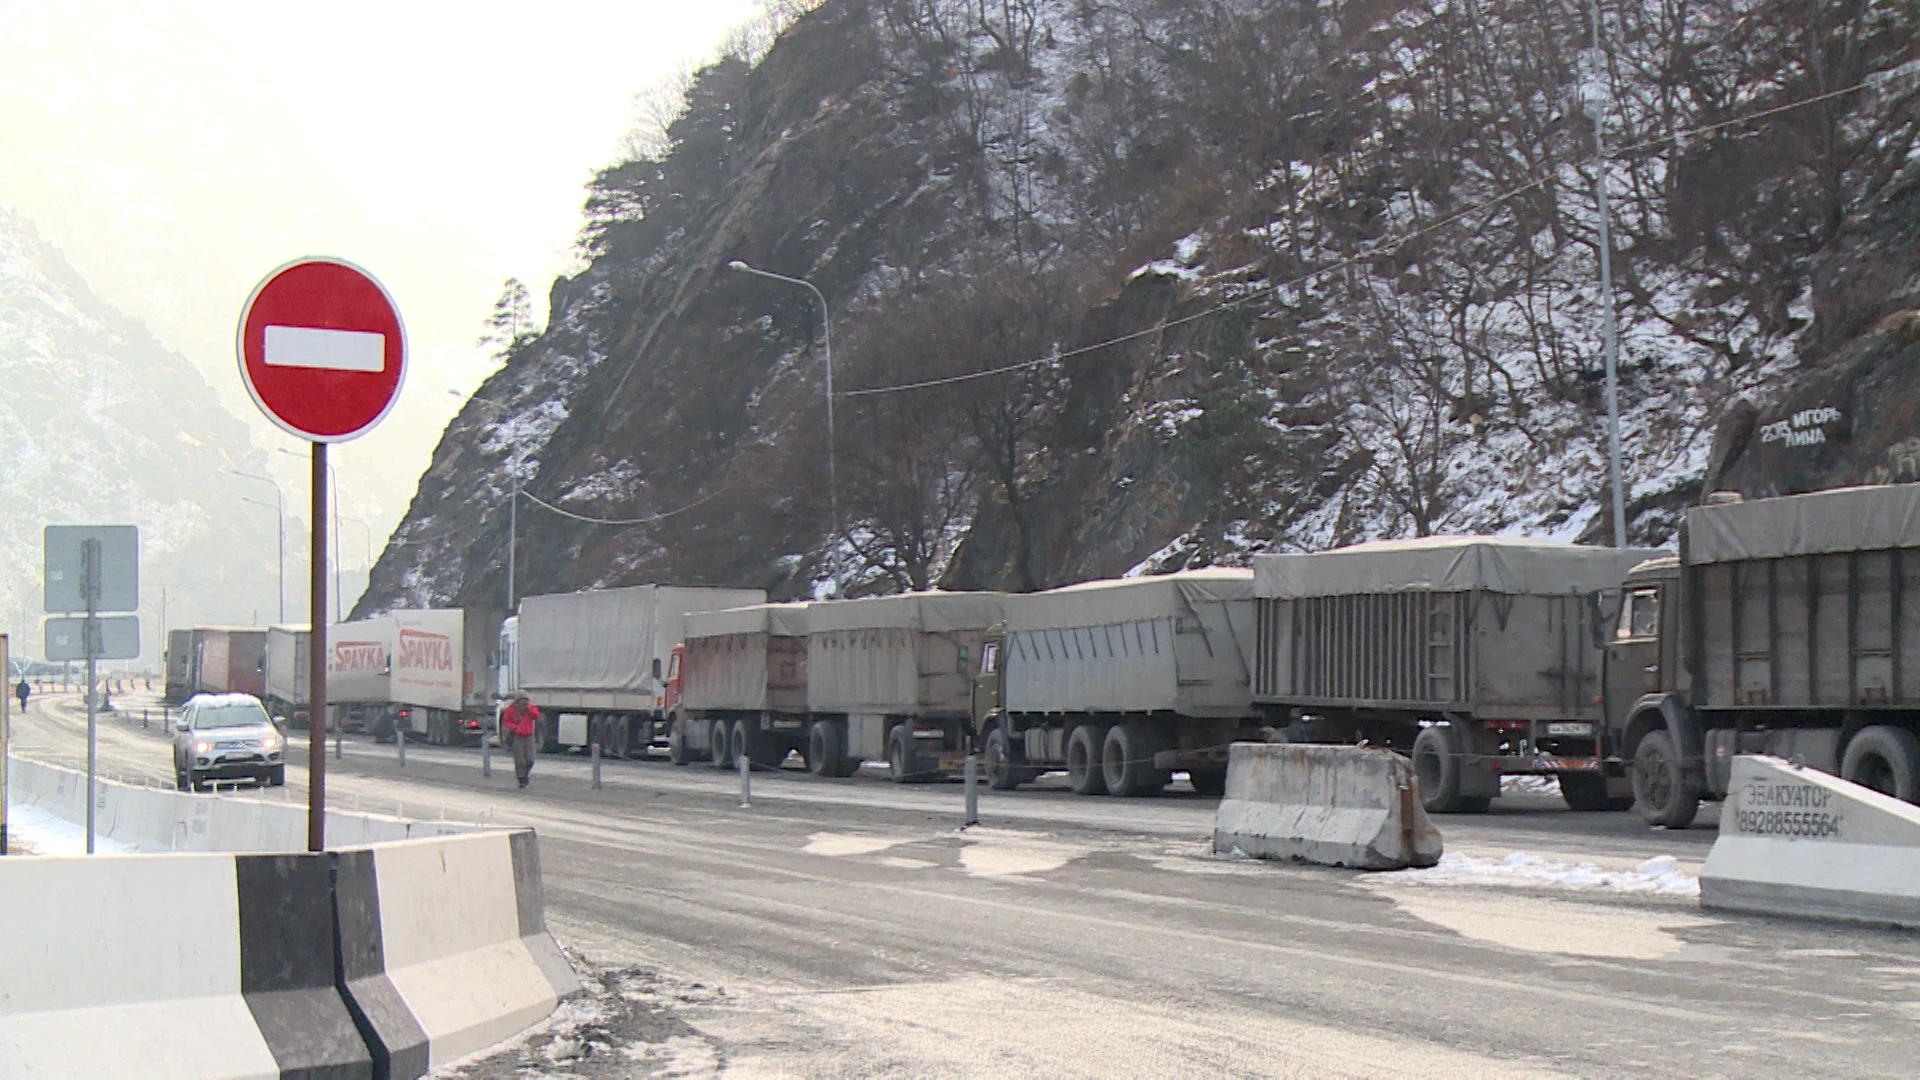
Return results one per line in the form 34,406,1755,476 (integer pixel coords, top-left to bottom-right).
0,208,280,638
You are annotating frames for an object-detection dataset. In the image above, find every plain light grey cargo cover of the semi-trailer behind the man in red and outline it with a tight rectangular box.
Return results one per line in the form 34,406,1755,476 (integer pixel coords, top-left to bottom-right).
518,584,766,709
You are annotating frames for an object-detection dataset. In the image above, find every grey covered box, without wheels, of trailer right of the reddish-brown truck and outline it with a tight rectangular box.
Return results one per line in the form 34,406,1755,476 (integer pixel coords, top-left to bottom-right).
806,592,1008,717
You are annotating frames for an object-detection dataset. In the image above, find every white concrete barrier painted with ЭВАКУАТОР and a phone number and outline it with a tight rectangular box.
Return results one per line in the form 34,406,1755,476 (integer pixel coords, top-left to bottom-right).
1699,755,1920,926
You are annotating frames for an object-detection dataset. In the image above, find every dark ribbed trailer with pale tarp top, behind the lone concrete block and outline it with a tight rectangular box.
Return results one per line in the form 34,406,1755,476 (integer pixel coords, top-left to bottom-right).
1254,536,1668,813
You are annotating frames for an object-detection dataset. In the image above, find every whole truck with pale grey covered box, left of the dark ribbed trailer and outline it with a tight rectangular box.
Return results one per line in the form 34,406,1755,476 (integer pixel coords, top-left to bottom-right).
972,569,1261,796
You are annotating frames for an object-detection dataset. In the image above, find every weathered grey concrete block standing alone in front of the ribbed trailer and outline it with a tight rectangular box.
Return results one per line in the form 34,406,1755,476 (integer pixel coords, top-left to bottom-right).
1213,742,1440,871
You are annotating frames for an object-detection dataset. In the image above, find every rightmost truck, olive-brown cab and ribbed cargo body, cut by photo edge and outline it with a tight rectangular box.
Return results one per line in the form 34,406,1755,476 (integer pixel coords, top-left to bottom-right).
1605,484,1920,828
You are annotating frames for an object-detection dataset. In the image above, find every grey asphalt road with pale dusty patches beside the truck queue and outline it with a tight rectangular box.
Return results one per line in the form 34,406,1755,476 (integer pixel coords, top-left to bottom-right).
15,687,1920,1080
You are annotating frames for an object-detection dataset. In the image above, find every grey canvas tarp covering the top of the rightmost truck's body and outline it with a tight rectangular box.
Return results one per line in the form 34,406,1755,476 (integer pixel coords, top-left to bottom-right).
1686,484,1920,563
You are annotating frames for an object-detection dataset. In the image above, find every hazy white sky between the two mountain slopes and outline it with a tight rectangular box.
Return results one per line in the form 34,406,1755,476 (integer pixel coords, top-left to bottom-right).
0,0,758,565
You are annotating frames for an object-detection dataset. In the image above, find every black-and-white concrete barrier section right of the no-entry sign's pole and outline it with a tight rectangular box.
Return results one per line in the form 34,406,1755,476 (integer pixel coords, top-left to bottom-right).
334,830,580,1076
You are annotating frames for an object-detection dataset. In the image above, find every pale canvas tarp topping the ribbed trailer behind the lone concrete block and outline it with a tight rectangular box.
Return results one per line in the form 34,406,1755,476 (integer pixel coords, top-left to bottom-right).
1254,536,1670,600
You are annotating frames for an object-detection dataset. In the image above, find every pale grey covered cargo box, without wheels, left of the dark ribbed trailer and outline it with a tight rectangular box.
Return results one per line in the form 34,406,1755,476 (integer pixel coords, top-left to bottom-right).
1002,567,1254,717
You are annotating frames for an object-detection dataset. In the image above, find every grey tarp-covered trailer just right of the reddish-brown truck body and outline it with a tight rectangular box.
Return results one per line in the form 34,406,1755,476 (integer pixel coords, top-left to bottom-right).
804,592,1010,784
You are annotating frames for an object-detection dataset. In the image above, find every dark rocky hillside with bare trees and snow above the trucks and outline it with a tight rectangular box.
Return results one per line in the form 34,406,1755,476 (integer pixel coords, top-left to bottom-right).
363,0,1920,607
